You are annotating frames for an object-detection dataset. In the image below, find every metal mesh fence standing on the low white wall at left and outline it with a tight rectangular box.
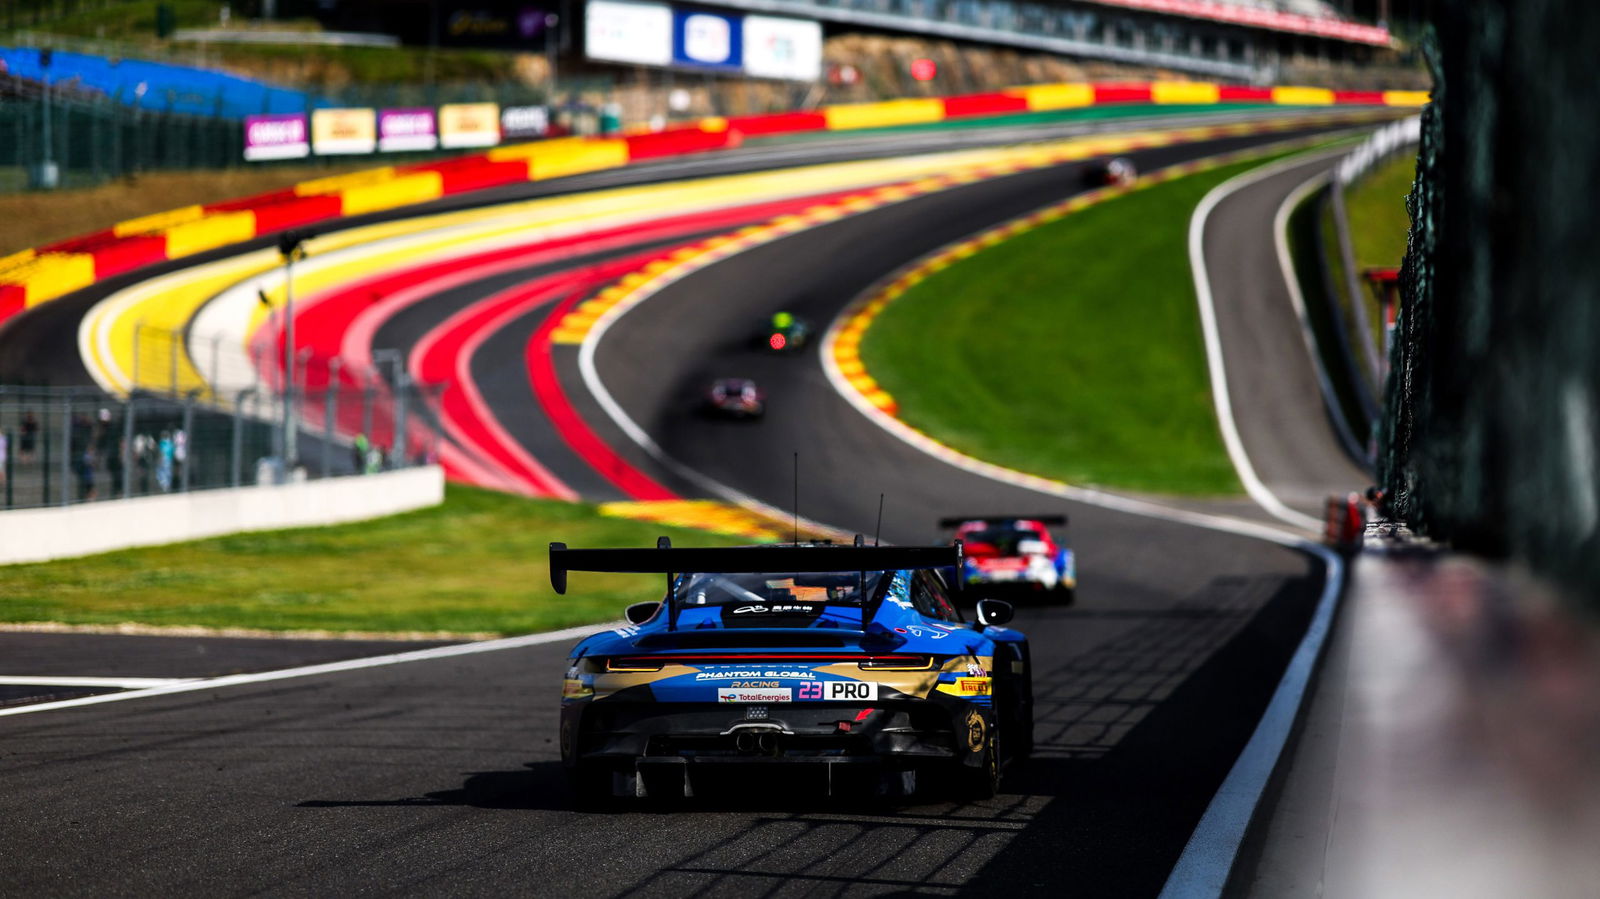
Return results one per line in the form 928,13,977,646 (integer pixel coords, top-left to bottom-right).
0,328,443,509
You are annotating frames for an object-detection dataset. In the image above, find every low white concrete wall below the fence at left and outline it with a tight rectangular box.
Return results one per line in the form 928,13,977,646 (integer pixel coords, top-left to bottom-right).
0,465,445,565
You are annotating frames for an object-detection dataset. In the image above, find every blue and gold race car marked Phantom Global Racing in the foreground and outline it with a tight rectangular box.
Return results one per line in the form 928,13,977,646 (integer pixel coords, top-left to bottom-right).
550,537,1034,798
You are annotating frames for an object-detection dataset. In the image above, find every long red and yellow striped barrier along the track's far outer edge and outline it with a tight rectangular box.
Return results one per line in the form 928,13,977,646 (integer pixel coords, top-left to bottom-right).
0,82,1427,323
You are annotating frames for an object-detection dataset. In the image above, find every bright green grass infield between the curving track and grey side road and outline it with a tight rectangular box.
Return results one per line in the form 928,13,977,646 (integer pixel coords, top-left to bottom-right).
862,150,1324,496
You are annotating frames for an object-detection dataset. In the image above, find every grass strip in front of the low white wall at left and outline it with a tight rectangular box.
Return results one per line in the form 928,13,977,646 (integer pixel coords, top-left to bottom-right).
0,485,749,633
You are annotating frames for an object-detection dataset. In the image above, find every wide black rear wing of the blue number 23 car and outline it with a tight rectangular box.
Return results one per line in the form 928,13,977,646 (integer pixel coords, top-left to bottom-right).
550,542,962,593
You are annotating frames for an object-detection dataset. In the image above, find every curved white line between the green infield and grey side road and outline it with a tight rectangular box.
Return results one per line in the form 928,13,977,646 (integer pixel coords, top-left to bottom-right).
1189,149,1347,533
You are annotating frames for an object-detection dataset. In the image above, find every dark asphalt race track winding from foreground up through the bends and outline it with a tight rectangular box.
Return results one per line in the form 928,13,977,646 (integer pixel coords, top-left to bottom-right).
0,117,1388,896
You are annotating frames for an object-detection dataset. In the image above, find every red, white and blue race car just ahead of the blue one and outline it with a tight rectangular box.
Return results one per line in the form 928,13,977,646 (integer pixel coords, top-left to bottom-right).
939,515,1078,603
